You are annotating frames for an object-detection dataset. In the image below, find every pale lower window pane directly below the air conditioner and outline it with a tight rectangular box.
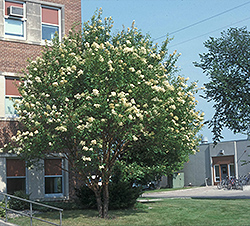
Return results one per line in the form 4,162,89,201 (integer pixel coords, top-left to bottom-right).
5,19,24,37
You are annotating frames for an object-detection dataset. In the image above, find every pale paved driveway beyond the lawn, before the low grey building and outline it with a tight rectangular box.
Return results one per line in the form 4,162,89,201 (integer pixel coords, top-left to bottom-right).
142,186,250,199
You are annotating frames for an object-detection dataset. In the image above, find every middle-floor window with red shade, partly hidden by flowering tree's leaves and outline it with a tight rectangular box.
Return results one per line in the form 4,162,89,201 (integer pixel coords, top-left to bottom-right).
5,78,21,117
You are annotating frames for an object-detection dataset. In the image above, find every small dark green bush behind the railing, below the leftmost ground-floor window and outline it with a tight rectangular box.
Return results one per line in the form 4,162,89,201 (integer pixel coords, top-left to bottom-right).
9,191,30,210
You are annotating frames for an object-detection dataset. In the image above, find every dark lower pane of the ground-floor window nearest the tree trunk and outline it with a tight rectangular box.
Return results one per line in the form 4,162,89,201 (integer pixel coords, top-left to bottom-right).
45,177,62,194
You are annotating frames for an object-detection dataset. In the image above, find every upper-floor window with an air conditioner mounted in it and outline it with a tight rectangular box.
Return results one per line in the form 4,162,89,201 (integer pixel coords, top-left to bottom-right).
4,0,25,38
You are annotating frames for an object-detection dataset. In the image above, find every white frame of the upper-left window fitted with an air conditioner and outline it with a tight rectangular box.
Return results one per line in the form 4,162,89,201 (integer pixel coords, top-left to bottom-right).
3,0,27,40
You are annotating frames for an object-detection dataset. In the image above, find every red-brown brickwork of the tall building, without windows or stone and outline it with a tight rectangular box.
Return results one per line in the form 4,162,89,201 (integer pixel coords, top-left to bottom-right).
0,0,81,200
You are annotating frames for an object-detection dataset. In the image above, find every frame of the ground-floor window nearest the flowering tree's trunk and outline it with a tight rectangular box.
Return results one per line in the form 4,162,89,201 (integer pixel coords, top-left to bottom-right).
44,158,65,198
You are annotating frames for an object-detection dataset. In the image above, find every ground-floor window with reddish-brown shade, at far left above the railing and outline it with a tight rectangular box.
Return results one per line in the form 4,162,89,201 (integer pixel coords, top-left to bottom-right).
6,159,26,194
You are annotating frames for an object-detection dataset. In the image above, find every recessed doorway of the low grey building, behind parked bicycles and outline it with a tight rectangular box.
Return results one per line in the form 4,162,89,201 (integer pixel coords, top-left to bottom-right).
212,155,235,185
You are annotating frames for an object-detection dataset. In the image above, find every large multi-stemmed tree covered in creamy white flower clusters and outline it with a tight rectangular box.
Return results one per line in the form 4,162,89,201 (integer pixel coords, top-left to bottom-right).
6,10,203,217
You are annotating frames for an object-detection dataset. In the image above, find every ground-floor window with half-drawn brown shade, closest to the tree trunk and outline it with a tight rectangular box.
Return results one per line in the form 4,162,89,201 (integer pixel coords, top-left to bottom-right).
44,159,63,194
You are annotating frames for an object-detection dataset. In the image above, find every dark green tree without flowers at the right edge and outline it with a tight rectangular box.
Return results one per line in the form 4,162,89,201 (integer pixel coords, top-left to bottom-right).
194,28,250,142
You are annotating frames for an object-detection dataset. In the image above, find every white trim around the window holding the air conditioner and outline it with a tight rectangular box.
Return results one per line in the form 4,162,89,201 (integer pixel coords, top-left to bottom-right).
3,0,27,40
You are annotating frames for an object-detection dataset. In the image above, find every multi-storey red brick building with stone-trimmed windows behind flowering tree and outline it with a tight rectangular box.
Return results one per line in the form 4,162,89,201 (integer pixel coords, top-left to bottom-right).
0,0,81,199
